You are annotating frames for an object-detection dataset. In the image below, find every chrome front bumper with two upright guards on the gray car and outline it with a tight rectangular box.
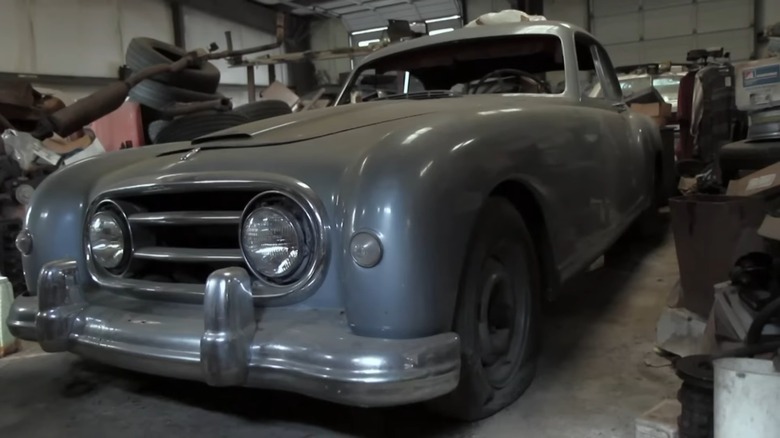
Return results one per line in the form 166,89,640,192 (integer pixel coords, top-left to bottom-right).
7,261,460,407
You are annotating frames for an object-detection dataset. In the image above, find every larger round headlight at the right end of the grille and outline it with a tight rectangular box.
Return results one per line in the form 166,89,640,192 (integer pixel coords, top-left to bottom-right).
241,206,304,278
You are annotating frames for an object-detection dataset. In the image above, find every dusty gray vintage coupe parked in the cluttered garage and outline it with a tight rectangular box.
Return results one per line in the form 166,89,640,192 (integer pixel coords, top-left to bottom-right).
7,22,668,420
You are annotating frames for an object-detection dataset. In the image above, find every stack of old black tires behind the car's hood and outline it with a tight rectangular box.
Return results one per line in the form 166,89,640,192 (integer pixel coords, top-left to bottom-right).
125,38,291,143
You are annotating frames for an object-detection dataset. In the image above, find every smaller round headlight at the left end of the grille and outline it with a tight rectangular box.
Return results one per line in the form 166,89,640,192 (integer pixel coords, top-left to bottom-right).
88,211,127,270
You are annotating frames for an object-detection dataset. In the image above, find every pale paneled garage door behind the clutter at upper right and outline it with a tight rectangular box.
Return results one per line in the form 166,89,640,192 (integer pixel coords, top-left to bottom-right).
591,0,755,66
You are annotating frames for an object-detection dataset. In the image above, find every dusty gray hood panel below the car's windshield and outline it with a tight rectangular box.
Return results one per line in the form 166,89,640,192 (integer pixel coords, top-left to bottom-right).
183,95,564,151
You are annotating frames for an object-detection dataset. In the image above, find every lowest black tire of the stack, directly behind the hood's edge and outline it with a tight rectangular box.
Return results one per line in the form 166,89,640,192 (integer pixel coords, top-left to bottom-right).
156,112,249,143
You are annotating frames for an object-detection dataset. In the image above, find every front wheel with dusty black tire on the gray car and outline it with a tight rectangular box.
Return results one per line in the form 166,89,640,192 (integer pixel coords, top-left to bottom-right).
428,198,541,421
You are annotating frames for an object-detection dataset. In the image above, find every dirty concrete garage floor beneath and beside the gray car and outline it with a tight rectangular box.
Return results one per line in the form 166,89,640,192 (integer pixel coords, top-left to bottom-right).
0,231,679,438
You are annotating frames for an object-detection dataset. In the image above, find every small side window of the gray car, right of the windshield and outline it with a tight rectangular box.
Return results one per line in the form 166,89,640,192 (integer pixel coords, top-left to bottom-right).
575,37,622,101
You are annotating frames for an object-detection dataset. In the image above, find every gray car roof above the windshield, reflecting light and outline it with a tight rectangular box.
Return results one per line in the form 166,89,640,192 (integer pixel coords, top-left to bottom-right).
360,21,590,65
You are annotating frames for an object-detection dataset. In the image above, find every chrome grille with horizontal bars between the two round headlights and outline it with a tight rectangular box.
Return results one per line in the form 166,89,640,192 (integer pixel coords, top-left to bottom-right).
85,183,327,302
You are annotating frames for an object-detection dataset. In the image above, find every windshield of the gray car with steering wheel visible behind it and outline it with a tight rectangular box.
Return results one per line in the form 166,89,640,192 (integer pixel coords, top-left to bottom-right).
339,35,565,104
